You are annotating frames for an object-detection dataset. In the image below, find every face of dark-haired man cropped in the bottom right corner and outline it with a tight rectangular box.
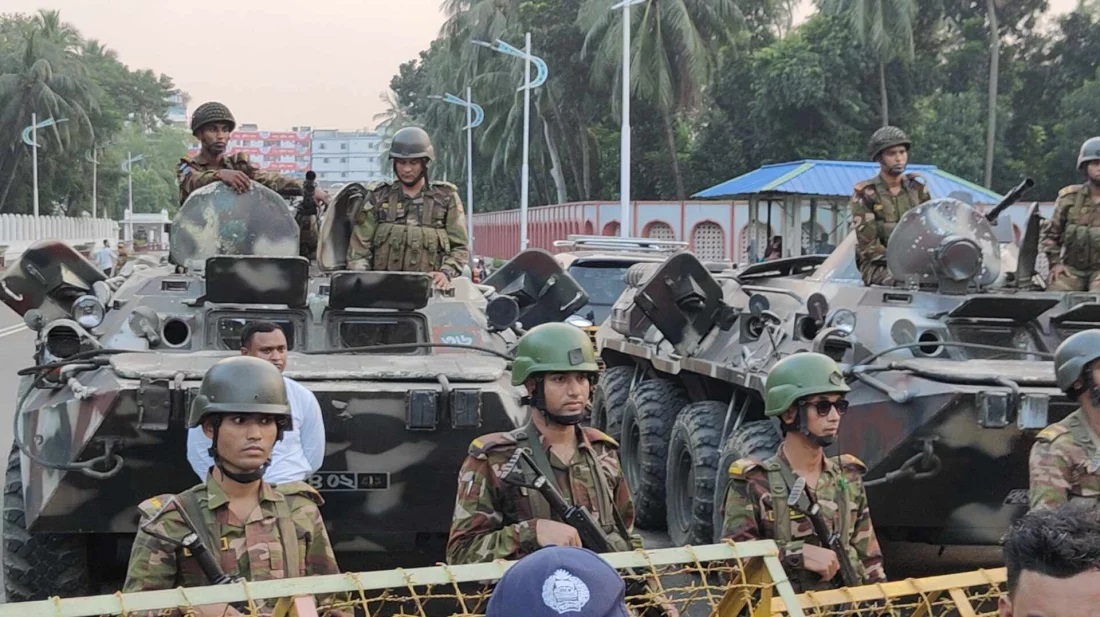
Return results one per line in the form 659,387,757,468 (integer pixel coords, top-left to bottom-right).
1000,570,1100,617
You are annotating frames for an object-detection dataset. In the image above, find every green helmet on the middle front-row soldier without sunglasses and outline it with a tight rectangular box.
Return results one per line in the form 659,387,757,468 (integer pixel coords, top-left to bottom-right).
512,322,600,386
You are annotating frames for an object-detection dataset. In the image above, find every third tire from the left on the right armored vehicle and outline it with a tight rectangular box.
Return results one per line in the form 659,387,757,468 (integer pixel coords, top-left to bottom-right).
664,400,728,547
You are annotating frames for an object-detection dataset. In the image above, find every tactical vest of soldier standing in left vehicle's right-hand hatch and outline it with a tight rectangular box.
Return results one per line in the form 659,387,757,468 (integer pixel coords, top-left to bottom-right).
372,185,451,272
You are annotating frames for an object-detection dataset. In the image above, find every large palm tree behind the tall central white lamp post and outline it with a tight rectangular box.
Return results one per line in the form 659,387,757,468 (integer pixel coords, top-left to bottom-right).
578,0,741,200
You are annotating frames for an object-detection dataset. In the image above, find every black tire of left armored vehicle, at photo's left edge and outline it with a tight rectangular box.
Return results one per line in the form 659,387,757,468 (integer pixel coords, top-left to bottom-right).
3,447,91,603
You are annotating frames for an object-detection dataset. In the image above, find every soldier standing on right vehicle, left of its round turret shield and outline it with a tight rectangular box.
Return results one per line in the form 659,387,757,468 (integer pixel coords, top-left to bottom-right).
850,126,932,285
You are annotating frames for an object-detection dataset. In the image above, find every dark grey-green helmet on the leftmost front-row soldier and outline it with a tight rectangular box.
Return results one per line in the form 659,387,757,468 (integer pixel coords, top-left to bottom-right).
187,355,293,430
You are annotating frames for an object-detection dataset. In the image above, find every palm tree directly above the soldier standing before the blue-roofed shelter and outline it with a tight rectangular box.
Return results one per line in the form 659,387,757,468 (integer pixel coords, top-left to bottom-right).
821,0,917,126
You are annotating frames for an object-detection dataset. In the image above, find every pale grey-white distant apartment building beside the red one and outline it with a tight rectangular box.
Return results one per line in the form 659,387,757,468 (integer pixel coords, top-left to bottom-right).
312,130,391,187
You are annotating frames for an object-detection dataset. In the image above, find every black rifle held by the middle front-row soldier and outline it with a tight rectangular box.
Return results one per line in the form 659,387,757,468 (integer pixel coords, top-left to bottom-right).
501,448,668,617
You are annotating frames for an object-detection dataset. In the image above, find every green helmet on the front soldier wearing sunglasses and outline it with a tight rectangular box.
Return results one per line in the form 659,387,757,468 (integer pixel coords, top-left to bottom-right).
765,352,851,418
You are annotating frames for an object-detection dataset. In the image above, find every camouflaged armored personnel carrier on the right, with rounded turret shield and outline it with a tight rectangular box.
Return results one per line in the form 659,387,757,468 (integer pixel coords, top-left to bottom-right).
593,183,1100,544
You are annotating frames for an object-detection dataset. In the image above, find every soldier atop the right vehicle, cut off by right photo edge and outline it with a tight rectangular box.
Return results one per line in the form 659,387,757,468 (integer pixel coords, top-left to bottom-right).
1040,137,1100,291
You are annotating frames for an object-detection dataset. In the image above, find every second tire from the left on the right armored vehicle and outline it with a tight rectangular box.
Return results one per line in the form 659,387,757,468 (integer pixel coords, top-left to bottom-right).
619,379,691,529
